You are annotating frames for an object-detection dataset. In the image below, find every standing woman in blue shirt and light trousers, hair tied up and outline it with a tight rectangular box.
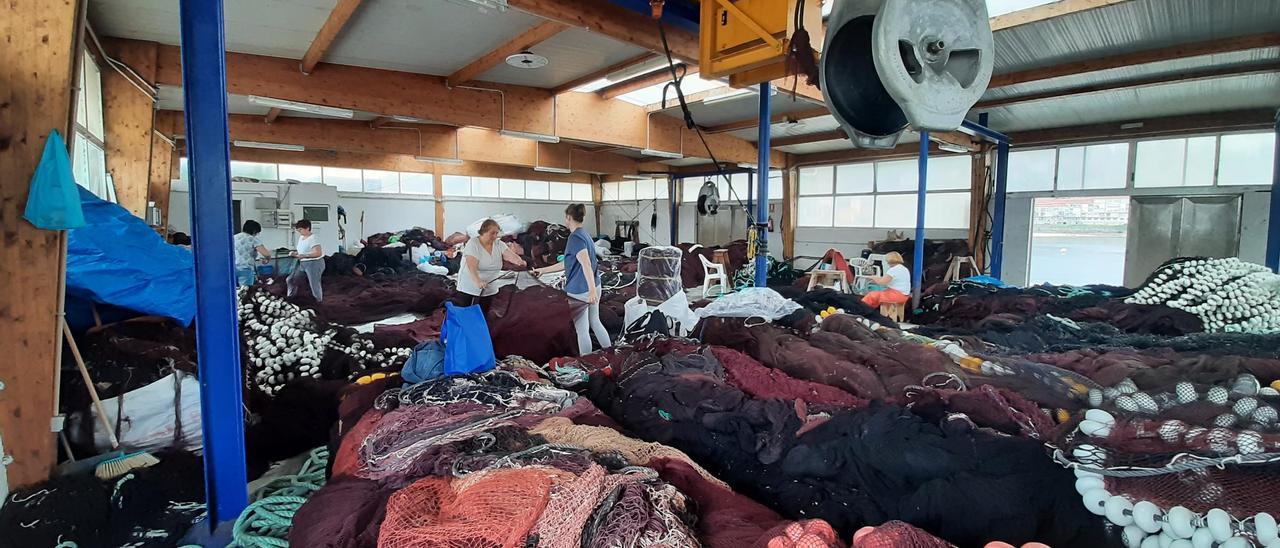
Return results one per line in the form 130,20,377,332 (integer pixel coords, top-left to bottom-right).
534,204,613,356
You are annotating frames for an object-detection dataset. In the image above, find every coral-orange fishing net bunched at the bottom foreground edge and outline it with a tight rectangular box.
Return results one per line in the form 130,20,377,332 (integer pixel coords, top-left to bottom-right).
378,469,552,548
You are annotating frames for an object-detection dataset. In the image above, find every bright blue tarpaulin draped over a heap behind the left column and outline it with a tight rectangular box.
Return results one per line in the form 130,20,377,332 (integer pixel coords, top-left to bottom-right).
67,187,196,325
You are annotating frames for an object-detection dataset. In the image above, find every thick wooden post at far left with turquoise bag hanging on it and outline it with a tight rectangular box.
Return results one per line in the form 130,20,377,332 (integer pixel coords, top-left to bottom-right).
0,0,77,489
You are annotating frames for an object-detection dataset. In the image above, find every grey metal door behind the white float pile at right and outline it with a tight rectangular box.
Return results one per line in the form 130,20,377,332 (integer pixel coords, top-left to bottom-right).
1124,195,1240,287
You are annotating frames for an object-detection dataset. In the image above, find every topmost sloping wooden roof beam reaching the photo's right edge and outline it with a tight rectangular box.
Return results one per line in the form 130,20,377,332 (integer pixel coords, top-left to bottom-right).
987,32,1280,88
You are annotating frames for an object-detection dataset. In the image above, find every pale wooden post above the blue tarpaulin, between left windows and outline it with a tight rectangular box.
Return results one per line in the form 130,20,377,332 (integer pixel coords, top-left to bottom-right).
100,40,157,218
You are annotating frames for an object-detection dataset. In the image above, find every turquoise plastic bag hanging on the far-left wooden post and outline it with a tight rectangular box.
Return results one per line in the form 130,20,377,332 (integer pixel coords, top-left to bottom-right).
22,129,84,230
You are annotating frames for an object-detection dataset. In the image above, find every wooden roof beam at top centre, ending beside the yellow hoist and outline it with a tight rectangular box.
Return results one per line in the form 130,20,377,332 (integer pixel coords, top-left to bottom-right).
507,0,700,63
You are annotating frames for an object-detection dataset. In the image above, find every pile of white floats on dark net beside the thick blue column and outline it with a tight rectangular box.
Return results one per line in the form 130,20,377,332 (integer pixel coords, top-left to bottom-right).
238,287,411,396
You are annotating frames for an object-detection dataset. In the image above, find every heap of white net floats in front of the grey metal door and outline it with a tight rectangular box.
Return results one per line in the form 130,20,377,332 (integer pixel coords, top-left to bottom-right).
1125,257,1280,333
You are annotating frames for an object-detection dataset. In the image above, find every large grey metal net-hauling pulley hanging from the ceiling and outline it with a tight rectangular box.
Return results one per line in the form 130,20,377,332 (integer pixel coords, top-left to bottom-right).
819,0,993,149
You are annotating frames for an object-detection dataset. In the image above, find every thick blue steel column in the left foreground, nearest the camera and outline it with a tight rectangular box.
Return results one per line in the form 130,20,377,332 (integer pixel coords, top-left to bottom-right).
179,0,248,526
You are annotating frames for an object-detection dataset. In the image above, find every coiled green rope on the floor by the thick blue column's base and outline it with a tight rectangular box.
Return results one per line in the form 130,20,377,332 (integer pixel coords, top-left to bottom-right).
230,447,329,548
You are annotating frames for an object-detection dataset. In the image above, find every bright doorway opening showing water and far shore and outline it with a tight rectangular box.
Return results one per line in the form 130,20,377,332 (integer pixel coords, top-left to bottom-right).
1029,196,1129,286
